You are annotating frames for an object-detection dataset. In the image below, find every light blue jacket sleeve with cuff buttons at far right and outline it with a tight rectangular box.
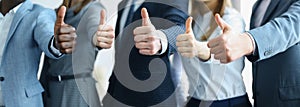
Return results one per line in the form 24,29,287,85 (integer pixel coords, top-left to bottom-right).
248,1,300,61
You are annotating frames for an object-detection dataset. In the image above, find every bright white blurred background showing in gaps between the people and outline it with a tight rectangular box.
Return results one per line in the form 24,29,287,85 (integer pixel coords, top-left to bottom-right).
32,0,256,103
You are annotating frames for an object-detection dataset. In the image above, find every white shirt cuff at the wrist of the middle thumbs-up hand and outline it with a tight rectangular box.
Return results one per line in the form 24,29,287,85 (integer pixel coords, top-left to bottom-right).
155,30,168,55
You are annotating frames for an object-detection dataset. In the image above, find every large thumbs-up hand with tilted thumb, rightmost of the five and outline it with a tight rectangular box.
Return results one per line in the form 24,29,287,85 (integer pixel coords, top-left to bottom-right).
208,14,254,63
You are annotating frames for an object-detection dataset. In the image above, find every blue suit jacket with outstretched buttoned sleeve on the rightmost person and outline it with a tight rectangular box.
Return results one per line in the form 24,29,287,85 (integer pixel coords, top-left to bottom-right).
248,0,300,107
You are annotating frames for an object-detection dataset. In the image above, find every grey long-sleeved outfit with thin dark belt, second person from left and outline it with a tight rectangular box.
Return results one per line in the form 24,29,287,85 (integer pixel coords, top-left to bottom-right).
40,1,104,107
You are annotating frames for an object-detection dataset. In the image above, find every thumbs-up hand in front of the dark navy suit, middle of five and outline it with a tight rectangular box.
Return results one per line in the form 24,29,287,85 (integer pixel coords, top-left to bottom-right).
133,8,162,55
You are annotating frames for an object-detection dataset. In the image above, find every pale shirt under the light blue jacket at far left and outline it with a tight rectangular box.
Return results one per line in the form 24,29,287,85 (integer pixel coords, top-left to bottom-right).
0,3,22,106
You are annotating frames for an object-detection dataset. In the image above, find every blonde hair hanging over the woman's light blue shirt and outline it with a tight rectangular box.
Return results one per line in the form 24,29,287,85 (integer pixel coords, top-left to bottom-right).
191,0,231,41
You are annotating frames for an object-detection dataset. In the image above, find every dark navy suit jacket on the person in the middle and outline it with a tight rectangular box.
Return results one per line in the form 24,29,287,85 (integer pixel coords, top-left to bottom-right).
104,0,188,107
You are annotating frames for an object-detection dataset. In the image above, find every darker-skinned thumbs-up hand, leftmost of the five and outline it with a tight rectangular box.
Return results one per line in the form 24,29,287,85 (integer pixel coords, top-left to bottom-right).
54,6,77,54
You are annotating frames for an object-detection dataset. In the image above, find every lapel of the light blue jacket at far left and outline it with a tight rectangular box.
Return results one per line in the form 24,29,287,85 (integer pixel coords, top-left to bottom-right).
6,0,33,43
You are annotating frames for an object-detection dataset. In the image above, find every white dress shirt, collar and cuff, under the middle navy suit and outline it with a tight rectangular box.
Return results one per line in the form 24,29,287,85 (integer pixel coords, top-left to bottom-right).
117,0,168,55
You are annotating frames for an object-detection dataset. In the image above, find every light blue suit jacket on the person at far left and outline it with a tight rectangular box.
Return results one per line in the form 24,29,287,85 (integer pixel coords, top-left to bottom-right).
0,0,56,107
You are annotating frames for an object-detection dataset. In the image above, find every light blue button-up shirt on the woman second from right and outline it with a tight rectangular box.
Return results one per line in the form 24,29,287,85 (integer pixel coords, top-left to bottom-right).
182,8,246,101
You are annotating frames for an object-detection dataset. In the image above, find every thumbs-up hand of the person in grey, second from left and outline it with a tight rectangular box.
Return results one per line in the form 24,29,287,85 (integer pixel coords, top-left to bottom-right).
93,10,115,49
